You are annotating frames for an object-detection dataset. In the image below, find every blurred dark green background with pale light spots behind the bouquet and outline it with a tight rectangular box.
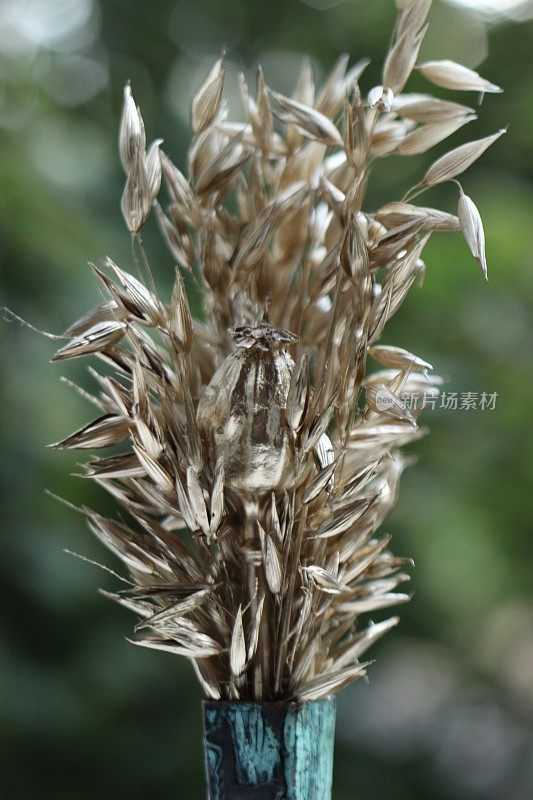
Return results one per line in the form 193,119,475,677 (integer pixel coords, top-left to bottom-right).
0,0,533,800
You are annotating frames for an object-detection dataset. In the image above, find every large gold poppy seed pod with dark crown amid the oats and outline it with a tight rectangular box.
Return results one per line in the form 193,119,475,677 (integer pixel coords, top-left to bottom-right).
198,324,296,494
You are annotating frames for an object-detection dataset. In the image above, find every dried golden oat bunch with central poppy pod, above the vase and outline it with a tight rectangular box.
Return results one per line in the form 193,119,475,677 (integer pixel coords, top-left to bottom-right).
47,0,502,699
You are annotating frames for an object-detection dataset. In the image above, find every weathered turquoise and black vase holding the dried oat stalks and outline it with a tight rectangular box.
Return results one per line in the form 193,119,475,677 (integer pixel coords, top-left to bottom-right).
203,697,336,800
